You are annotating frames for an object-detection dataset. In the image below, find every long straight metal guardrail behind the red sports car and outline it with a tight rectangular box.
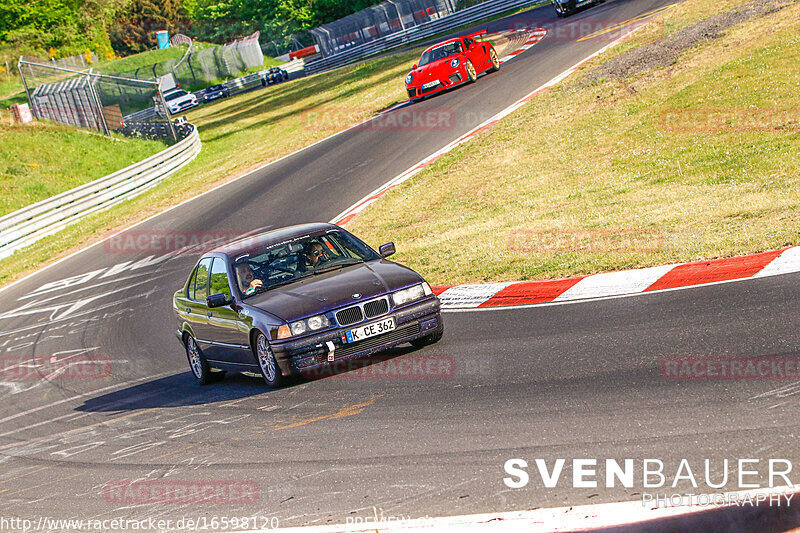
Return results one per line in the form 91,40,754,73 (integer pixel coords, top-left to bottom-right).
305,0,542,74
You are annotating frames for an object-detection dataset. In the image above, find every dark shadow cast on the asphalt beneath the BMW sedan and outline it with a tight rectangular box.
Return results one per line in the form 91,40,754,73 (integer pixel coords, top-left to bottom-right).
76,346,419,413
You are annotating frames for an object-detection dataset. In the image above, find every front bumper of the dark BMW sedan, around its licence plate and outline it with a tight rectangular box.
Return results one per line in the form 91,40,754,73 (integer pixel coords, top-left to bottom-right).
271,296,442,376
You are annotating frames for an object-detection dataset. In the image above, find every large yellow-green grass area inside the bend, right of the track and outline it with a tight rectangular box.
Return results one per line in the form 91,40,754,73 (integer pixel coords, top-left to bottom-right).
348,0,800,283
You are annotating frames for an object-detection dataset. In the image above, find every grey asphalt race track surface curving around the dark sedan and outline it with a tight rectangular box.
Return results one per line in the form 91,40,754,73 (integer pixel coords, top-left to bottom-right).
0,0,800,526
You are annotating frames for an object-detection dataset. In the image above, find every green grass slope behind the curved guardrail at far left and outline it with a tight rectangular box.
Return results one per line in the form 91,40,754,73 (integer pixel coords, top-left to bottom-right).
0,117,165,216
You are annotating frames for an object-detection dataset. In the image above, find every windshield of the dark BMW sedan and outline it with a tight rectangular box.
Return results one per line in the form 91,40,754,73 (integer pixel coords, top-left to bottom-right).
233,230,380,298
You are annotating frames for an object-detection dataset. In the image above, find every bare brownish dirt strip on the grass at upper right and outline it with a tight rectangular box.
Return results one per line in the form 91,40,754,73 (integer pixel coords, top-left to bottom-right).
586,0,797,83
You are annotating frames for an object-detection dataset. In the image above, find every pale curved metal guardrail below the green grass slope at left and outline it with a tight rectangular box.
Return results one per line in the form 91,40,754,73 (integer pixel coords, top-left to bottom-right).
0,126,201,259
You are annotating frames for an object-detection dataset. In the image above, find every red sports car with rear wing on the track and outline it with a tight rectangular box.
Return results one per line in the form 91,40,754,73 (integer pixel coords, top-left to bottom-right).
406,31,500,102
